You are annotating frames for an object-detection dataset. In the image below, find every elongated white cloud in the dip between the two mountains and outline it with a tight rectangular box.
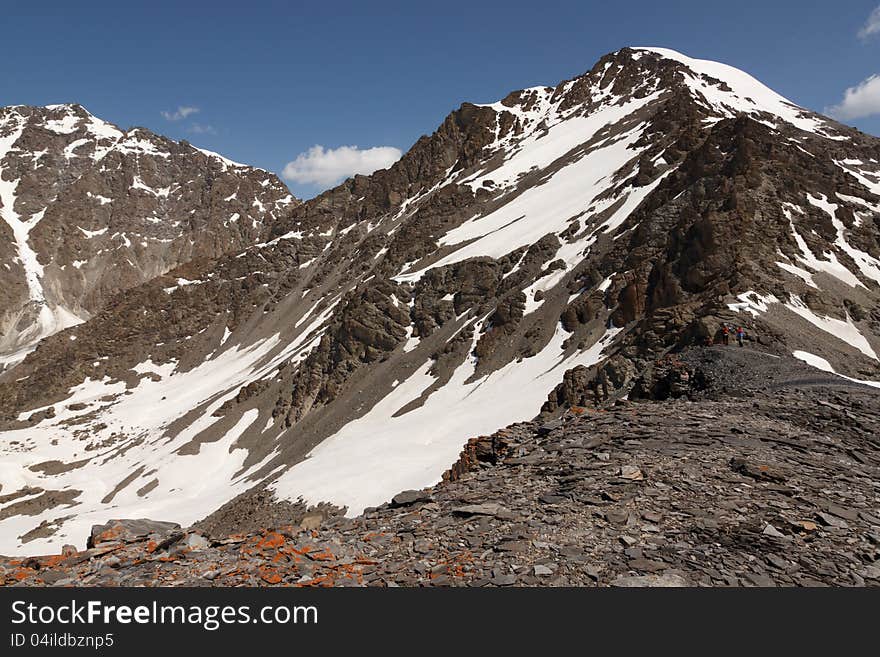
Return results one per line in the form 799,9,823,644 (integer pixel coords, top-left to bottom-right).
282,145,402,186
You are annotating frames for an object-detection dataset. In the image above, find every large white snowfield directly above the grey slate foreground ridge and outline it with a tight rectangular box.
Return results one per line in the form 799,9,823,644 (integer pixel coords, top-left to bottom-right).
271,326,620,516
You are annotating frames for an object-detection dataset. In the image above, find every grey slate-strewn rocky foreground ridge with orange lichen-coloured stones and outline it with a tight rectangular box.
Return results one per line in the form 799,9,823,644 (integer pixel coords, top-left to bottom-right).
0,346,880,586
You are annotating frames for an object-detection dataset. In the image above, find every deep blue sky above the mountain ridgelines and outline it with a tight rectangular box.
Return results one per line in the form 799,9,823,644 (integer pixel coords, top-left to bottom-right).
0,0,880,197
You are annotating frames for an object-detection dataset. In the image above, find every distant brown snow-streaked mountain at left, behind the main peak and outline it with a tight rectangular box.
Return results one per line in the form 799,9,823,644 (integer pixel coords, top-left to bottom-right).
0,105,294,365
